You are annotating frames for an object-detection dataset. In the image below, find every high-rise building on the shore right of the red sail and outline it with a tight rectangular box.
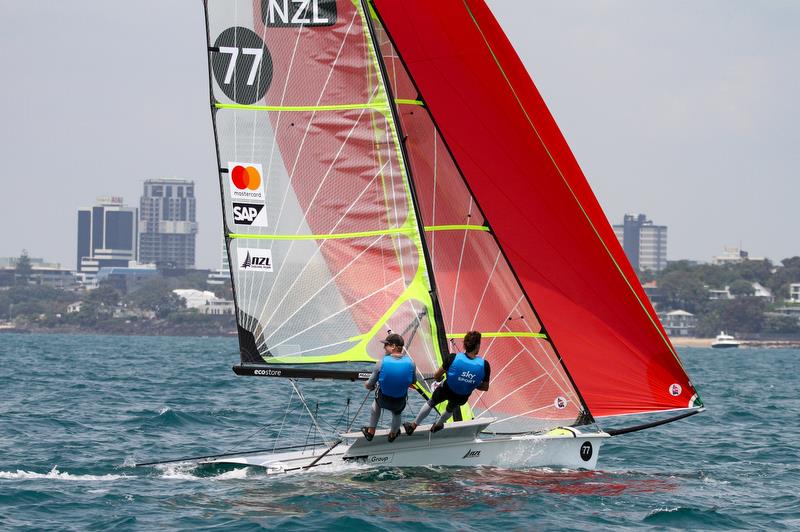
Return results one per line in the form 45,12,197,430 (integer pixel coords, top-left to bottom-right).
614,214,667,272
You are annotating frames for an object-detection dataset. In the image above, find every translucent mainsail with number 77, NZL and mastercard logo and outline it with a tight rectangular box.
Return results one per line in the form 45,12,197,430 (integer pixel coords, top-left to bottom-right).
206,0,447,371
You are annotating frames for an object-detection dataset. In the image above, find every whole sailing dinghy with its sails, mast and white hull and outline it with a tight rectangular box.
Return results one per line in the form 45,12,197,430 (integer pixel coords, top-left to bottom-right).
197,0,702,472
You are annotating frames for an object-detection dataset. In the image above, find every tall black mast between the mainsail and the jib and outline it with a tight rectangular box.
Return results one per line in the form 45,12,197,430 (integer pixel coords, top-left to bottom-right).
359,0,449,363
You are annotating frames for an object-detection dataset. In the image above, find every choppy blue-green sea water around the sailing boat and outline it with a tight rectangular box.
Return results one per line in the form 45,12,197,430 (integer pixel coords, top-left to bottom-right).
0,334,800,531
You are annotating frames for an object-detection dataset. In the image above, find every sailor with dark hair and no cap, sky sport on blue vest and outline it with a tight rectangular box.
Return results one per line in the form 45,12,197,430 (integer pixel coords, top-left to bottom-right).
403,331,491,436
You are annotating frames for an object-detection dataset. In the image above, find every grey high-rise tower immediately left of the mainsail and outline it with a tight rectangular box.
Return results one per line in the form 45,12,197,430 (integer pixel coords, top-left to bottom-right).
139,179,197,269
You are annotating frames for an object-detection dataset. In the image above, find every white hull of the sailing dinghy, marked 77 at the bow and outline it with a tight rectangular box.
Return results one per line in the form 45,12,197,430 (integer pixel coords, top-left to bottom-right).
202,420,609,473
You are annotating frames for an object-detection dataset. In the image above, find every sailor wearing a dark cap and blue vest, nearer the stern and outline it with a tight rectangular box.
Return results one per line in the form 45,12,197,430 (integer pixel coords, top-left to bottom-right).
361,334,417,442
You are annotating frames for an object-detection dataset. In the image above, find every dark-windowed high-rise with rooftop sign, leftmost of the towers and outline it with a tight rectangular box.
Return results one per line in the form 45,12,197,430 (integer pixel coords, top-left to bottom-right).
76,196,139,274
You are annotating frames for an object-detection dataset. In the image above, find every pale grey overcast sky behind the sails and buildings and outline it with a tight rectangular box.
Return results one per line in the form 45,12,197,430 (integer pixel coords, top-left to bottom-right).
0,0,800,268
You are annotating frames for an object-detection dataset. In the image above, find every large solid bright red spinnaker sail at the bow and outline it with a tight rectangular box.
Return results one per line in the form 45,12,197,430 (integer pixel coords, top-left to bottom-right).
375,0,695,416
